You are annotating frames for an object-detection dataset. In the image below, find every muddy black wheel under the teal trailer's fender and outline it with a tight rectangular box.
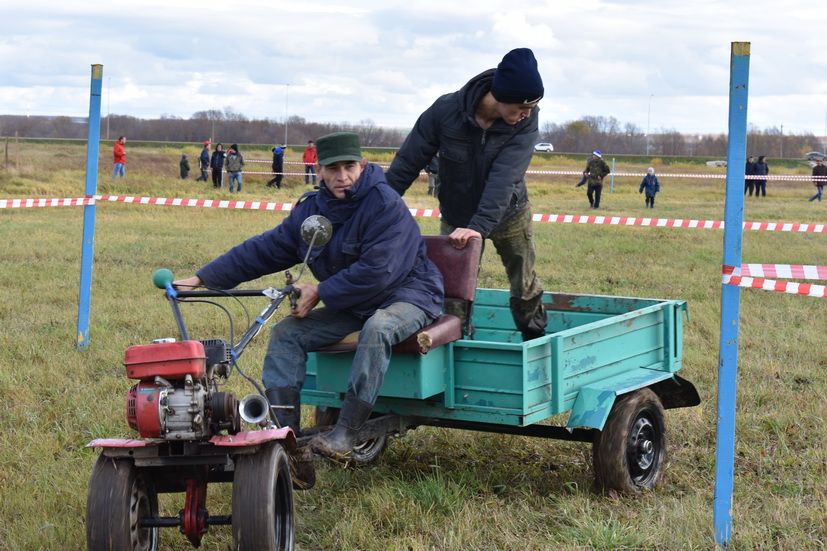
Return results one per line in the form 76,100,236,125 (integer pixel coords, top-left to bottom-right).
592,388,666,494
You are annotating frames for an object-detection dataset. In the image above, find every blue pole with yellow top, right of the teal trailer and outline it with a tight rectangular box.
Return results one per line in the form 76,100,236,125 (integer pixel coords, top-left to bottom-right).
712,42,750,546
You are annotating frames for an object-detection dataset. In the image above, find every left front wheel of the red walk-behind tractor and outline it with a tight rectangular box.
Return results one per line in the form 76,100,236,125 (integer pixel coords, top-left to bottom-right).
86,454,159,551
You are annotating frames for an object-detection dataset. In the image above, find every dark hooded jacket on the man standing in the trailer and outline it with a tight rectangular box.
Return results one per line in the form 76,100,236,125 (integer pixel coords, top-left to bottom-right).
387,69,539,237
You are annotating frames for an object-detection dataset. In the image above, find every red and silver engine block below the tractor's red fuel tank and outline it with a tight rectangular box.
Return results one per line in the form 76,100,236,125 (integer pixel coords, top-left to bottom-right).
126,375,209,440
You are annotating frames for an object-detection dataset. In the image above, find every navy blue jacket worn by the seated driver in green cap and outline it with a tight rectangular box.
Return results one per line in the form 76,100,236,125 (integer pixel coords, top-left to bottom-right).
198,164,443,318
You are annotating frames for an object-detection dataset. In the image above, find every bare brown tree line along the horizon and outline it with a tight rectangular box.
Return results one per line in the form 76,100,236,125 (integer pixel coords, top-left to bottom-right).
0,108,823,158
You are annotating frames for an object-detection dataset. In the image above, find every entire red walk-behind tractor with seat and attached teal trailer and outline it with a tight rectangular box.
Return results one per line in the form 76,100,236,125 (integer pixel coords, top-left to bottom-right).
87,212,700,550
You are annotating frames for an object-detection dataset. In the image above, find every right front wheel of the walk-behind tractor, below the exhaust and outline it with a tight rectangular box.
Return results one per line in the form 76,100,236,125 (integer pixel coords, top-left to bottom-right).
233,442,294,551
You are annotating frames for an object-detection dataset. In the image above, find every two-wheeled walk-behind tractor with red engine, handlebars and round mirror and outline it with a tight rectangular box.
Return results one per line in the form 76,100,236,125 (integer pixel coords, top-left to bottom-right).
86,217,331,551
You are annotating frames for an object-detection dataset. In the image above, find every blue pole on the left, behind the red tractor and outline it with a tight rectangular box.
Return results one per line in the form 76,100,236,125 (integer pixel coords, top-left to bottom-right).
77,65,103,349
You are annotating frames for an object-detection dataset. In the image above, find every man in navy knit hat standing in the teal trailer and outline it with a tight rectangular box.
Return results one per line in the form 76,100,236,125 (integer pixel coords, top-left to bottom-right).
386,48,547,341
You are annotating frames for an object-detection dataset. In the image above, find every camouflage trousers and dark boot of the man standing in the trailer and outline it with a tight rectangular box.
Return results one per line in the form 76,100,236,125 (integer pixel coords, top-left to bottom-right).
439,205,547,341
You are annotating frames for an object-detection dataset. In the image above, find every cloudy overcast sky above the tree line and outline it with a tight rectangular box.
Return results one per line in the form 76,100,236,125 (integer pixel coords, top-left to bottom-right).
0,0,827,136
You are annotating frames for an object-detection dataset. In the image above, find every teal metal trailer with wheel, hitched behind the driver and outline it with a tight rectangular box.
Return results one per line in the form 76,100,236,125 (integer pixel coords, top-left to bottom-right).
302,289,700,492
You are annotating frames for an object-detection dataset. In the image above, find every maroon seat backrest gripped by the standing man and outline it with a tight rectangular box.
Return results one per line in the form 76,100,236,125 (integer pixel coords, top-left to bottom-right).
423,235,482,302
